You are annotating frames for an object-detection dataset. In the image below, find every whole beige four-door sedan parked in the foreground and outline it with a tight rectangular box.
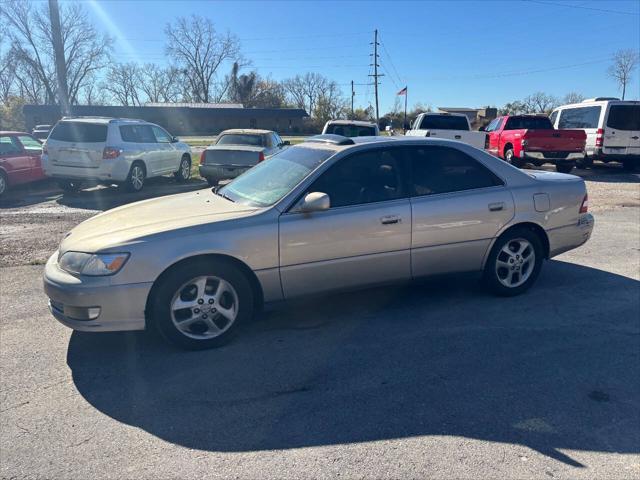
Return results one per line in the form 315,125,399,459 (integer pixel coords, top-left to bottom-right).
44,135,594,349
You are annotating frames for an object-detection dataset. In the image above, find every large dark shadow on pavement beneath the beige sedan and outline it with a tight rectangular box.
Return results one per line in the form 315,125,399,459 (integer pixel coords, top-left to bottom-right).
67,261,640,467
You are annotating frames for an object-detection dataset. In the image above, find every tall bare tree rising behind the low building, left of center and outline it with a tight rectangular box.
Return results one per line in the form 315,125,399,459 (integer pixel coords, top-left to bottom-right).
164,15,240,103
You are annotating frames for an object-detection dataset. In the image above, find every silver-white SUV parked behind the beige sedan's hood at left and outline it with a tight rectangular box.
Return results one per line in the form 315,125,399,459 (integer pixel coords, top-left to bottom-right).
42,117,191,192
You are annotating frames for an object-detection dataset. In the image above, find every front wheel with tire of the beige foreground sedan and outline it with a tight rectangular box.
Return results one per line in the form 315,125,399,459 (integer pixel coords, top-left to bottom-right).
151,260,254,350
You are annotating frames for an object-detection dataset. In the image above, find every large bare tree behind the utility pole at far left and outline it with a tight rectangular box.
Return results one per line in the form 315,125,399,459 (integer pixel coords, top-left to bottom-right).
0,0,112,103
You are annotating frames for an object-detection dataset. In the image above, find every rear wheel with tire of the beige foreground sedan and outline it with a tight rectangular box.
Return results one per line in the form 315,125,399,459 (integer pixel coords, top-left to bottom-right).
484,228,543,296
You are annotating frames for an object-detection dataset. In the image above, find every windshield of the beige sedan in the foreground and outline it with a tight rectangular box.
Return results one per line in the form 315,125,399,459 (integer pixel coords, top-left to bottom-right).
219,146,334,207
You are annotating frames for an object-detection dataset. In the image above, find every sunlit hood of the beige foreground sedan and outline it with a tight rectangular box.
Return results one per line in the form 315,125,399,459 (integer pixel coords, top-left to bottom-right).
59,189,257,253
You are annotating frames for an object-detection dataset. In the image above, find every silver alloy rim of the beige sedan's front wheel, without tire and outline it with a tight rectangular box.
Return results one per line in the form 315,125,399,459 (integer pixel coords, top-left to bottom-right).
170,276,239,340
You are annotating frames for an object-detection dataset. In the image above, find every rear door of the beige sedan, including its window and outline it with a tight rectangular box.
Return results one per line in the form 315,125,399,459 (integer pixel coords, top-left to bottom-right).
406,146,514,277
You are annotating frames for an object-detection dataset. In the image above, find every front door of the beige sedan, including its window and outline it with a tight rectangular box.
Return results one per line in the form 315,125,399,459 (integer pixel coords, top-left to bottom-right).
279,148,411,298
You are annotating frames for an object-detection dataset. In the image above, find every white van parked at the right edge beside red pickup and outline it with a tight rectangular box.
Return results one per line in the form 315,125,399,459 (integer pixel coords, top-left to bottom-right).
549,97,640,170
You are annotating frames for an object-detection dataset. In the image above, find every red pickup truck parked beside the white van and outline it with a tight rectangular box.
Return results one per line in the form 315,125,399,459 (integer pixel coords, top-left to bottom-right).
485,115,587,173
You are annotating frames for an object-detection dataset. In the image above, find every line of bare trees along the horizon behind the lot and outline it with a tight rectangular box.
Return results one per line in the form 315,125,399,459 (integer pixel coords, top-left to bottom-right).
0,0,638,129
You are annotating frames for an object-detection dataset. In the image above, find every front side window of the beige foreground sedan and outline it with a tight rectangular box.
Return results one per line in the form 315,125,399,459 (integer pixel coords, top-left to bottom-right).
309,148,407,208
